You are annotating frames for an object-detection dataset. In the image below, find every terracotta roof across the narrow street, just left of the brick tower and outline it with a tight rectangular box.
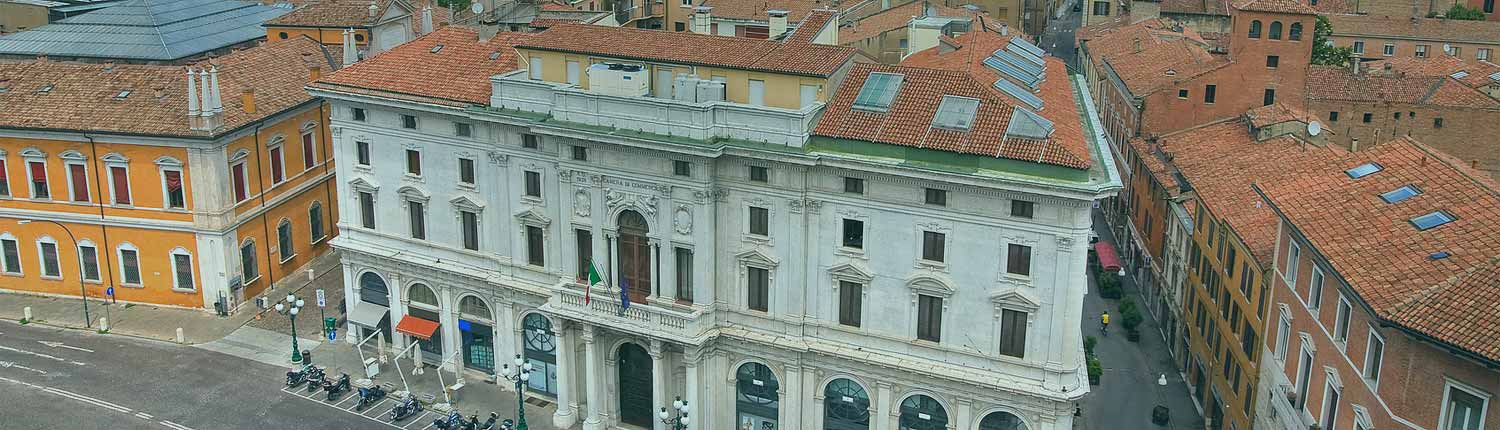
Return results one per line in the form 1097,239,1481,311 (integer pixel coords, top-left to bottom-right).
1088,18,1230,97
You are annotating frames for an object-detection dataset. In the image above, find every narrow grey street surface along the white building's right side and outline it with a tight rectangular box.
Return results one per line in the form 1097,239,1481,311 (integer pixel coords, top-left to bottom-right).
1076,214,1203,430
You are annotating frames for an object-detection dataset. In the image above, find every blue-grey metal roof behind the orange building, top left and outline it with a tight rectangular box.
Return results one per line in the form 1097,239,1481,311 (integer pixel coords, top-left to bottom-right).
0,0,290,61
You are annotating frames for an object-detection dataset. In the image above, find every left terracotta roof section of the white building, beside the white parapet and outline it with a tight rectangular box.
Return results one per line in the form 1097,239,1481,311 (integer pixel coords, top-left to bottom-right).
312,27,536,106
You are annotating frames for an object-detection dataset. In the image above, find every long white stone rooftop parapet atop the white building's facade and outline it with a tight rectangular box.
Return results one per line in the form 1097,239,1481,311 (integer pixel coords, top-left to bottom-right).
489,70,824,148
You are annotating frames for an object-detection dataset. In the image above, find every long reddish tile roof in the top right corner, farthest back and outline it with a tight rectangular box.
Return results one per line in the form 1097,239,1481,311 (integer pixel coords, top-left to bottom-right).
1328,15,1500,45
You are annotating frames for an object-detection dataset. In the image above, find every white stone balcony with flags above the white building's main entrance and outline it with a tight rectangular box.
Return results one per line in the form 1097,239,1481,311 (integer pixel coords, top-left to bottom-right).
542,282,713,345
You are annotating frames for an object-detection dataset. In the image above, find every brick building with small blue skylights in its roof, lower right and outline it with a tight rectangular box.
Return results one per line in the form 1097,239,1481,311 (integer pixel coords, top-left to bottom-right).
1256,138,1500,430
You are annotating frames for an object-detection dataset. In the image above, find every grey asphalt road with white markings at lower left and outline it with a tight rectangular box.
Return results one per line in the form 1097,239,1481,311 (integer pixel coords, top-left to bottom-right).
0,321,387,430
